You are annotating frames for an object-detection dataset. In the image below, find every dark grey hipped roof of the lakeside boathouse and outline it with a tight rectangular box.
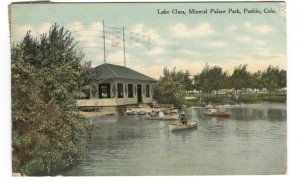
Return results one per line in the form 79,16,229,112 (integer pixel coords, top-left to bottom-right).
90,63,157,82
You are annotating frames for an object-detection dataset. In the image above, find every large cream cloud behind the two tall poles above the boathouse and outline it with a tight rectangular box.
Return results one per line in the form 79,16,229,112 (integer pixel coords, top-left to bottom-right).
63,22,167,66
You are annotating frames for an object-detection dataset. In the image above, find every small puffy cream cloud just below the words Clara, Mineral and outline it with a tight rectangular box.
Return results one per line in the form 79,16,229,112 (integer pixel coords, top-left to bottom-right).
170,22,215,38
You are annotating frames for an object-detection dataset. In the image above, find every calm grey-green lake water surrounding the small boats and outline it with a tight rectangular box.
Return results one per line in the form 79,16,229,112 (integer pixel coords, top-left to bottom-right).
59,104,287,176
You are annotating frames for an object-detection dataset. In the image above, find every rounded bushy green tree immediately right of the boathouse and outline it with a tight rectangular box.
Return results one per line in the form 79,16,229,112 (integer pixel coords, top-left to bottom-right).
154,68,188,107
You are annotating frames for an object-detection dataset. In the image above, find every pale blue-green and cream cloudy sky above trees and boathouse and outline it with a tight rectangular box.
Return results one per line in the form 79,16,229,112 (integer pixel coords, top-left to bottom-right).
11,2,287,79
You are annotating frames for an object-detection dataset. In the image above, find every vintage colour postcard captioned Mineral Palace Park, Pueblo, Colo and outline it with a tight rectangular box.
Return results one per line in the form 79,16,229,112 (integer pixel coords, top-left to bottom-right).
9,1,287,176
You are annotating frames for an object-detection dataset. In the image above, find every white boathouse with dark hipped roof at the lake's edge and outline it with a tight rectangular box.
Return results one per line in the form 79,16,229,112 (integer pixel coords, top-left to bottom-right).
77,63,156,110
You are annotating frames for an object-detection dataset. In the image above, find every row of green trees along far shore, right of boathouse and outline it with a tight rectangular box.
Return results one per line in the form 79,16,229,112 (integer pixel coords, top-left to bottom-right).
154,64,286,106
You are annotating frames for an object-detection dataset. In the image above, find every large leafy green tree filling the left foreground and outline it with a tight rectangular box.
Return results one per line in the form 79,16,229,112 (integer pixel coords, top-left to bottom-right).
11,24,90,174
